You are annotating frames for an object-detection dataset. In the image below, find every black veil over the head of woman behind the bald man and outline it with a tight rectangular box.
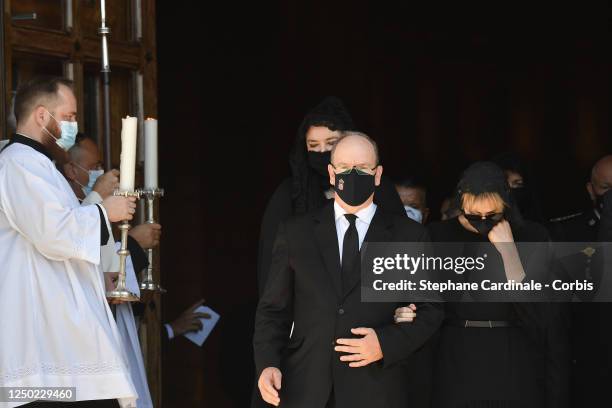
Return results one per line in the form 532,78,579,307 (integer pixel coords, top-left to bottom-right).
289,96,354,214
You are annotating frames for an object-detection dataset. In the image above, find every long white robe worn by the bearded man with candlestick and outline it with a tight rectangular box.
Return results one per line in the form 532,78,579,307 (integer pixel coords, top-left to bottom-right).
0,143,137,408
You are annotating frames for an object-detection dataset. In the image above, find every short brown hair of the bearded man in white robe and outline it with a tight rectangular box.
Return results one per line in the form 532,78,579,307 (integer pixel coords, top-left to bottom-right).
15,76,73,124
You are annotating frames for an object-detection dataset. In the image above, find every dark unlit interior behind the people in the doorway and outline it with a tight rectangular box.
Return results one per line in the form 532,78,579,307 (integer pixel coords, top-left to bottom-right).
157,0,612,407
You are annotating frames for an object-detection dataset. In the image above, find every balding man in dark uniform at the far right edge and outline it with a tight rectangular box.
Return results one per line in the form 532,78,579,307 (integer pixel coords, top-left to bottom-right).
551,155,612,408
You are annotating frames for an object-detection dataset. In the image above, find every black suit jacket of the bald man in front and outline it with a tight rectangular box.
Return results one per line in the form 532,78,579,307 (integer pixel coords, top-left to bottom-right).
253,202,442,408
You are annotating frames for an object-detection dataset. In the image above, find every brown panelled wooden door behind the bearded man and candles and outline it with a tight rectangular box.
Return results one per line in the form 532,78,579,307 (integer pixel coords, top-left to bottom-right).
0,0,161,407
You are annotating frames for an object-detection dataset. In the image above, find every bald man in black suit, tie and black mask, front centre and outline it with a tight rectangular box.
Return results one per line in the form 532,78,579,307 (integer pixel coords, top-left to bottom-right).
253,132,442,408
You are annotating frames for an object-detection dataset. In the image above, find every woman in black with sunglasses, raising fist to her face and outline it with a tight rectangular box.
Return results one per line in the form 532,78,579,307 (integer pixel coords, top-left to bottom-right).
395,162,567,408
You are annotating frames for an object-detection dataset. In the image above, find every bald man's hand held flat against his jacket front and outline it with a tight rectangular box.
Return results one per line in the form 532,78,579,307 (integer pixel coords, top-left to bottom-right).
334,327,383,367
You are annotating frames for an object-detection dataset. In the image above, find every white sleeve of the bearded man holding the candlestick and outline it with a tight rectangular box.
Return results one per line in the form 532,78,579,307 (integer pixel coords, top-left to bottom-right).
0,157,101,265
